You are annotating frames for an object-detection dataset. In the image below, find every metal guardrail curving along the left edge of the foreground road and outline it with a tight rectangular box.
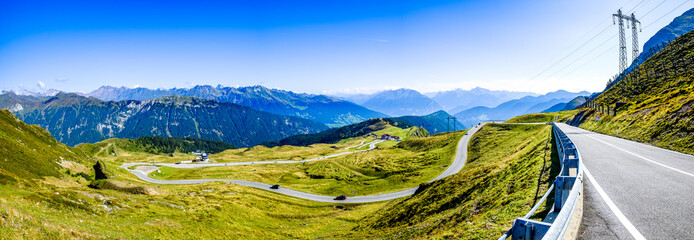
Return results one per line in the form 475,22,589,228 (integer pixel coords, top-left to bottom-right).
499,123,583,240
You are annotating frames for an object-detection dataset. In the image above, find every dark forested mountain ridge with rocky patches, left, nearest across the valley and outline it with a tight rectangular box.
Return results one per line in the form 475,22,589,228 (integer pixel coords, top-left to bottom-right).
0,93,328,147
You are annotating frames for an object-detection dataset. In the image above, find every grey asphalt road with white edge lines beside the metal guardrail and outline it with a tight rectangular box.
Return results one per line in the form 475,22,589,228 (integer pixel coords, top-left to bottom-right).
557,124,694,239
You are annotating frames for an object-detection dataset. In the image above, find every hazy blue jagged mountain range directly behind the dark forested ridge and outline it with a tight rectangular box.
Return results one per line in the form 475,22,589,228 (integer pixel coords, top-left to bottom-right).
86,85,387,127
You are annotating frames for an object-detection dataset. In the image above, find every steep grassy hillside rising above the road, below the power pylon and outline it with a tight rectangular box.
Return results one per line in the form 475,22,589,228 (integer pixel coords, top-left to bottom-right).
573,29,694,154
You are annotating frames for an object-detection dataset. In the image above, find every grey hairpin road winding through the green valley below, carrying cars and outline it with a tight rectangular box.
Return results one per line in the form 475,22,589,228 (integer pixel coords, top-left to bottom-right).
121,123,484,203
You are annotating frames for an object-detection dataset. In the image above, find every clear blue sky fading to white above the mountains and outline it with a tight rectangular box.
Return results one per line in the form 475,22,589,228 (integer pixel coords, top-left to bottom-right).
0,0,694,93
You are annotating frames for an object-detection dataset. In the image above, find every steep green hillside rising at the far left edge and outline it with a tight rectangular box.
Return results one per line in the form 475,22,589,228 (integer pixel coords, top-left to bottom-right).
0,109,90,184
